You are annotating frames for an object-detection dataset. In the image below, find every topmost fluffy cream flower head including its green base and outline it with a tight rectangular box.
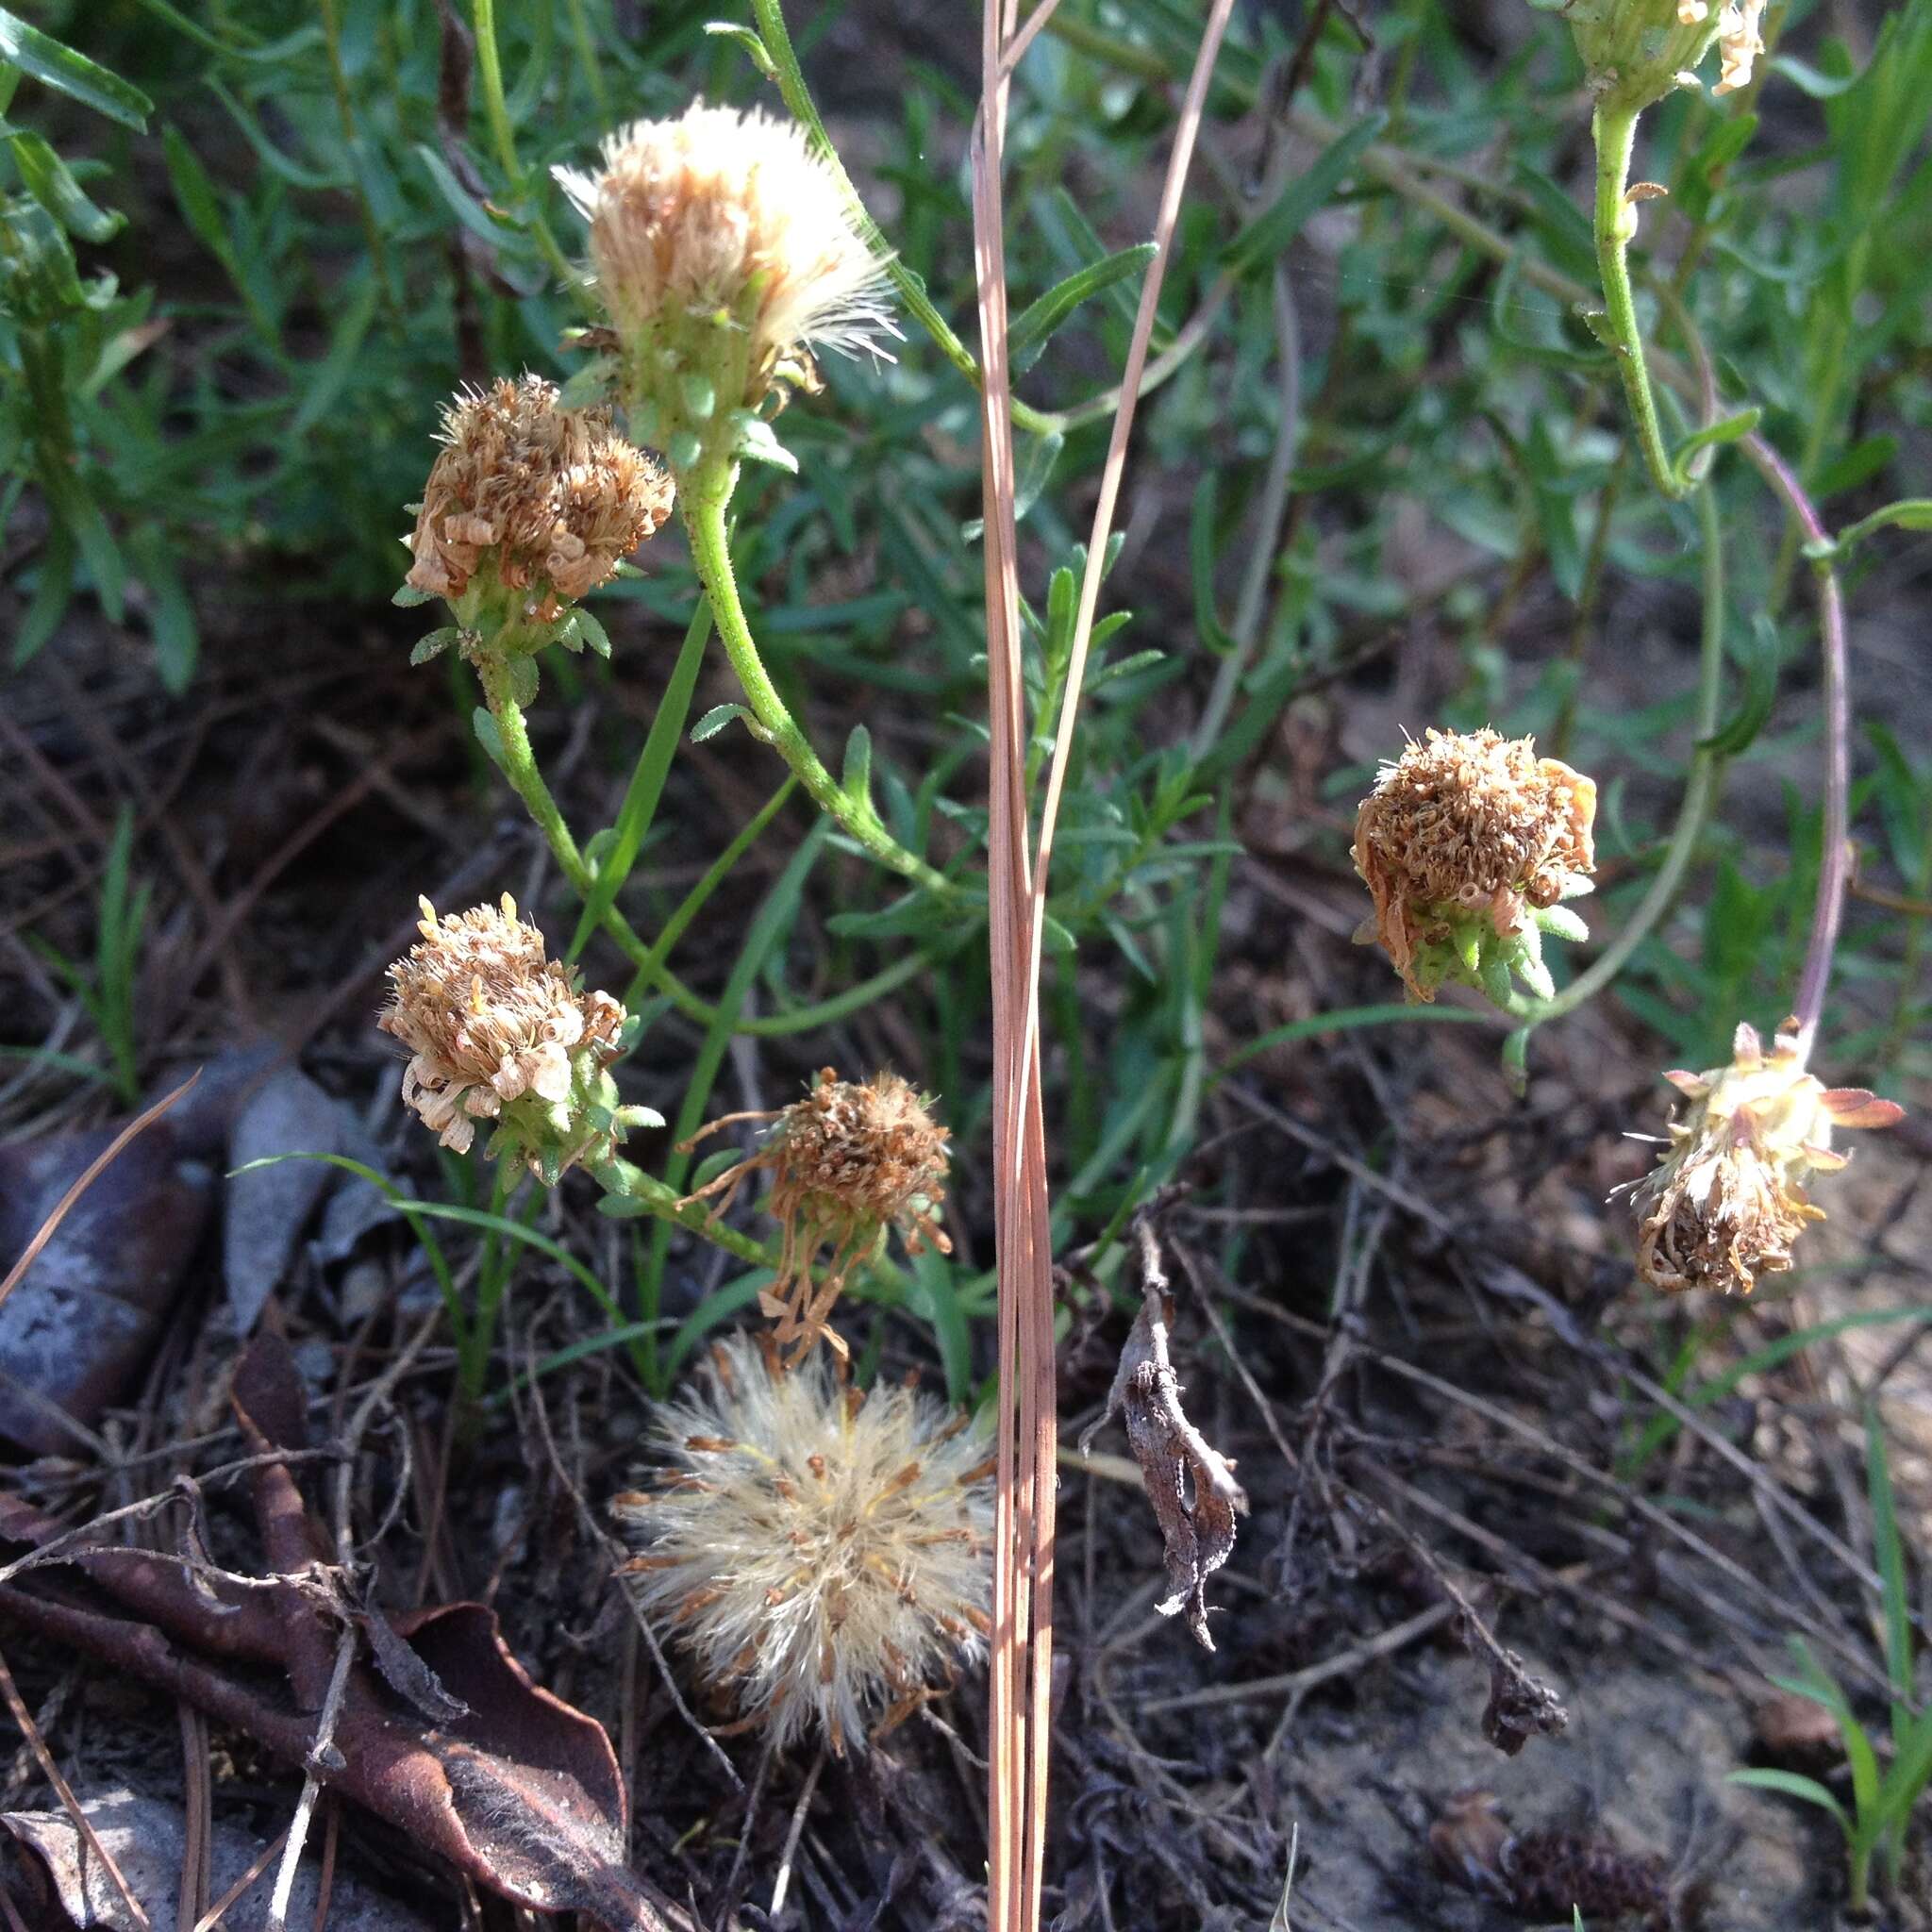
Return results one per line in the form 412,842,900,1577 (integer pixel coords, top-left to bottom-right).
557,100,898,466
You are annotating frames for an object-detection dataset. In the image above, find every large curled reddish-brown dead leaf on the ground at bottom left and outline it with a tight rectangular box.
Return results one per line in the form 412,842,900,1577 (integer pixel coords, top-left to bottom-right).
0,1335,684,1932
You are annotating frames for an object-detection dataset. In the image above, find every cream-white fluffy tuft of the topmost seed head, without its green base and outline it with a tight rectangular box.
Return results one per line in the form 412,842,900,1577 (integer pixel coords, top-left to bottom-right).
557,100,898,371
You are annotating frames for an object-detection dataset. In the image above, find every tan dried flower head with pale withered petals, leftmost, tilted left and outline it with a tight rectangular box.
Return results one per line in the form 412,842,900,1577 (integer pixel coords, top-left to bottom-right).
376,892,641,1182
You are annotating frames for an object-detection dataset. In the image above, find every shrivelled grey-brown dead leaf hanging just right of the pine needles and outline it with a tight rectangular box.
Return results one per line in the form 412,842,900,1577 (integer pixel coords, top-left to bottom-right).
1080,1215,1248,1650
